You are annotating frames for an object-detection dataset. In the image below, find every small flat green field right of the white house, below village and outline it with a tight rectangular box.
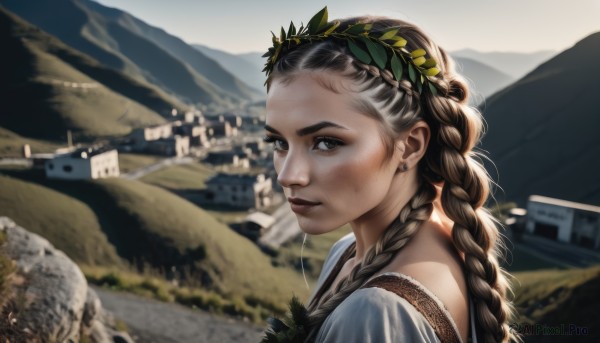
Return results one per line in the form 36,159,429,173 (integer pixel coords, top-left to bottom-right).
140,163,216,190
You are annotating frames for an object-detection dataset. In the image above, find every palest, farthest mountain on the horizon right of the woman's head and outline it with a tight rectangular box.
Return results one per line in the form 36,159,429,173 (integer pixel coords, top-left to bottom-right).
451,49,556,80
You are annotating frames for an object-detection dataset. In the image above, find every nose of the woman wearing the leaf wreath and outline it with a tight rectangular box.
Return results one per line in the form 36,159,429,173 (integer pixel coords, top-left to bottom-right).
275,149,310,188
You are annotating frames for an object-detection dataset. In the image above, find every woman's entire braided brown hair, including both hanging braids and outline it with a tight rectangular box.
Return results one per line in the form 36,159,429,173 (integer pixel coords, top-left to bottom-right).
267,17,514,342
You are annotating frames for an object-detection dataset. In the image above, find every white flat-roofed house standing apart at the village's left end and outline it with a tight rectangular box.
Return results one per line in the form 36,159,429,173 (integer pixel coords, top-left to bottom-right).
44,147,119,180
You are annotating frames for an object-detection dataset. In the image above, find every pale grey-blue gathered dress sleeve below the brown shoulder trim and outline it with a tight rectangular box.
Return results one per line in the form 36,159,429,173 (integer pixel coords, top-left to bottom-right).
316,287,440,343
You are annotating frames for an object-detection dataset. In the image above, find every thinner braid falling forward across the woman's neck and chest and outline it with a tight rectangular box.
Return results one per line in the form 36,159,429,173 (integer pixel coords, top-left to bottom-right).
309,182,436,339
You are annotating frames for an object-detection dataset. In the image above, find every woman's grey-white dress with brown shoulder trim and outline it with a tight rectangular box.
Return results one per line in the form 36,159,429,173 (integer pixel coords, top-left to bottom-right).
309,234,477,343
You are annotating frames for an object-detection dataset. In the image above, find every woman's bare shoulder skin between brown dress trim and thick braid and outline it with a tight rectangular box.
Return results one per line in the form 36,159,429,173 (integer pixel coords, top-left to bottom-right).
382,216,469,341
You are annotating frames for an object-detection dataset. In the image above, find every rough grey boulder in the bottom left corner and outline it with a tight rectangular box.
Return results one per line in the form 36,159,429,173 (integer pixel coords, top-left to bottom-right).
0,217,132,343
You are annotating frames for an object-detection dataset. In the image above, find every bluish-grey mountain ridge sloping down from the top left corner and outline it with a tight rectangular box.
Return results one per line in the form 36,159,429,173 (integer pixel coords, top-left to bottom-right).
3,0,257,105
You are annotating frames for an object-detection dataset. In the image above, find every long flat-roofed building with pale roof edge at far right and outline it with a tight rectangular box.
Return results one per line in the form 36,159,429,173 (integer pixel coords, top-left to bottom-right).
526,195,600,249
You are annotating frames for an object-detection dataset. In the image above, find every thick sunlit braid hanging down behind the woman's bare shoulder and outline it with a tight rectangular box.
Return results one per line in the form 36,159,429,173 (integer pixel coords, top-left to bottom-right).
424,80,512,342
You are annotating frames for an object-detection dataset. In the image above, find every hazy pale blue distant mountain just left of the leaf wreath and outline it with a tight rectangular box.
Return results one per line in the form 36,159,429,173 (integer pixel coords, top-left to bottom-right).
192,44,267,97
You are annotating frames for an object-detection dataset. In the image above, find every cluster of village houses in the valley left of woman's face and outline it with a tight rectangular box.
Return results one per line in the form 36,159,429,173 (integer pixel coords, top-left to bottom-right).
15,109,300,248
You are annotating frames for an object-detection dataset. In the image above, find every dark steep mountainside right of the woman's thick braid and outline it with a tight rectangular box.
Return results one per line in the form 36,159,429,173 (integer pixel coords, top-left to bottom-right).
482,32,600,205
